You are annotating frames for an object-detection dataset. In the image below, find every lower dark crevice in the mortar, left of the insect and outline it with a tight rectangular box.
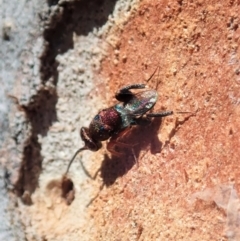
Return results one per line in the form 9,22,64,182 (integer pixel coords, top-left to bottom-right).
15,89,57,205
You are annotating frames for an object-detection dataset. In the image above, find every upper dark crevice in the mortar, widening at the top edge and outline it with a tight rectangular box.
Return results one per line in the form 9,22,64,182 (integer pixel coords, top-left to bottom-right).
40,0,116,84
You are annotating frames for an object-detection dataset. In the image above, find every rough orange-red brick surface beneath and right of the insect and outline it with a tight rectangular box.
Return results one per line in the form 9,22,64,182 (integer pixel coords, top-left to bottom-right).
95,1,240,240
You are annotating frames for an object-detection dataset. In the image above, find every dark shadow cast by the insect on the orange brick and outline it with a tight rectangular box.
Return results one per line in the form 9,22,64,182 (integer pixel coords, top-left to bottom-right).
99,118,162,187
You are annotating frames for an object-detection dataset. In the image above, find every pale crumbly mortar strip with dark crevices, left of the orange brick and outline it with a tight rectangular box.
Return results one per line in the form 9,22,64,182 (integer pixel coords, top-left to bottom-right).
0,0,141,240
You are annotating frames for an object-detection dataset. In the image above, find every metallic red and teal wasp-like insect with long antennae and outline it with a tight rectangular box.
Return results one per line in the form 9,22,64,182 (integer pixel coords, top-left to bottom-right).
66,80,173,174
